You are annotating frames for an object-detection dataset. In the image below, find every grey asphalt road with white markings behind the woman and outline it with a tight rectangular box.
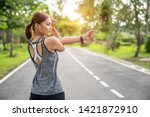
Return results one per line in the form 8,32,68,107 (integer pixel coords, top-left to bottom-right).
0,47,150,100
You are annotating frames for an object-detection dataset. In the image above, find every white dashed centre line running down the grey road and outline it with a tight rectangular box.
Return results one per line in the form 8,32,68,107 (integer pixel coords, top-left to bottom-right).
67,51,124,98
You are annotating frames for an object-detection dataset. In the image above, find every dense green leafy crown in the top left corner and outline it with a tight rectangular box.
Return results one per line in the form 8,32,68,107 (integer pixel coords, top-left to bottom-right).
0,0,40,30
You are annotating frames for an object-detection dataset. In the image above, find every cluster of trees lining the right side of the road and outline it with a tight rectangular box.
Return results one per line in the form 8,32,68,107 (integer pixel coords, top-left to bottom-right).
77,0,150,58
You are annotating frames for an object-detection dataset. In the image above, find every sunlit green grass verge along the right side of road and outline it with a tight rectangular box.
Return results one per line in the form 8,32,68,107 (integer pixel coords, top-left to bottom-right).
69,44,150,69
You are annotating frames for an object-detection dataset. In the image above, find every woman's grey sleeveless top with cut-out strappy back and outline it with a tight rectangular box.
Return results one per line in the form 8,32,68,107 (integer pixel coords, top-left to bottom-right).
28,37,64,95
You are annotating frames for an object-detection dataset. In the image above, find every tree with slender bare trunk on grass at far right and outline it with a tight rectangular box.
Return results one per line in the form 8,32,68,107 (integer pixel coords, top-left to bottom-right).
106,0,149,57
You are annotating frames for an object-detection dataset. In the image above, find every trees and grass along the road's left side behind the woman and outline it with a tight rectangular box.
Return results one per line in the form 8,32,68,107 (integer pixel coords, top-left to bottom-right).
0,0,49,79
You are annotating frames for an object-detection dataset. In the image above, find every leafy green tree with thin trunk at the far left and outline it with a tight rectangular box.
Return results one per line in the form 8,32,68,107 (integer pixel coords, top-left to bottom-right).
0,0,45,57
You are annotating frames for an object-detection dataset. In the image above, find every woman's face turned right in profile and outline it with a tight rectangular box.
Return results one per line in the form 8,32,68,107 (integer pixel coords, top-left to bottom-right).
38,18,51,35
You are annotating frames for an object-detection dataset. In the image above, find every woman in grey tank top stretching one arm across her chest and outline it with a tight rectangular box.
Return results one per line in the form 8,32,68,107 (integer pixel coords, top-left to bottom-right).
25,12,94,100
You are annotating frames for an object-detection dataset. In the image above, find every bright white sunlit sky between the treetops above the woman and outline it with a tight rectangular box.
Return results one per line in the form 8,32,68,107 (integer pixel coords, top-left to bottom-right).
43,0,85,26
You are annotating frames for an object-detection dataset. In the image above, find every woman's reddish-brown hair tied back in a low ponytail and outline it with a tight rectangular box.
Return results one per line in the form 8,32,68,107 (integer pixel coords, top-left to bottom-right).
25,12,49,39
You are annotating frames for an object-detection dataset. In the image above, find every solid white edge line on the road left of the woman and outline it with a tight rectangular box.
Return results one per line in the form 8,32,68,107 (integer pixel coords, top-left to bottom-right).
0,59,30,84
